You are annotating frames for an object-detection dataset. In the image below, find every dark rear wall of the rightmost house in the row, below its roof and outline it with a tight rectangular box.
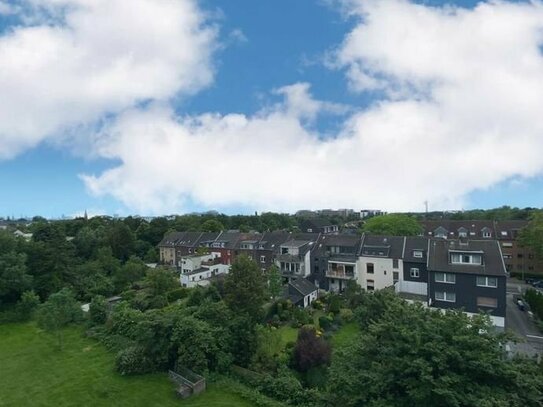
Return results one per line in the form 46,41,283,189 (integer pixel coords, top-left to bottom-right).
428,271,506,317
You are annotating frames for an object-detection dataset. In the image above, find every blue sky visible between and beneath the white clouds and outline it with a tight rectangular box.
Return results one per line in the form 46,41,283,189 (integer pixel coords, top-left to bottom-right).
0,0,543,217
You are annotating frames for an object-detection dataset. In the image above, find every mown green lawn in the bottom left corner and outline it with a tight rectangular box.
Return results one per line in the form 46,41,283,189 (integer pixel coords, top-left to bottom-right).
0,324,252,407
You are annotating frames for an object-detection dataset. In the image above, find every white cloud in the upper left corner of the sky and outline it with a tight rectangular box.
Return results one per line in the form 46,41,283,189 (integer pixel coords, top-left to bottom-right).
0,0,216,159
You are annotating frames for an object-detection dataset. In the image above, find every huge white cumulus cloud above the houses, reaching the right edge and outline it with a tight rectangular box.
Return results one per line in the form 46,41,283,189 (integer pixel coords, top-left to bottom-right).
83,0,543,213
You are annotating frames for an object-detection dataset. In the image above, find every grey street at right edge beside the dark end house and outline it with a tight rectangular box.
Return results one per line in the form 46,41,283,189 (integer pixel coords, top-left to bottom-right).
505,280,543,356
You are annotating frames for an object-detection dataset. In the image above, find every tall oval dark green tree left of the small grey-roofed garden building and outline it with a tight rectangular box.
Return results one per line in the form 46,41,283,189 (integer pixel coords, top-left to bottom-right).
224,256,266,321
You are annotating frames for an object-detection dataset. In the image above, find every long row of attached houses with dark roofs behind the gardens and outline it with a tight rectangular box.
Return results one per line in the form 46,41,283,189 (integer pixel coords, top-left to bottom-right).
159,232,506,327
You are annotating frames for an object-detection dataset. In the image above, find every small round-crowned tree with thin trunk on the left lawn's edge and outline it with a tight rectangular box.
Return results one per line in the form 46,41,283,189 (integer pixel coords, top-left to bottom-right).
38,288,82,350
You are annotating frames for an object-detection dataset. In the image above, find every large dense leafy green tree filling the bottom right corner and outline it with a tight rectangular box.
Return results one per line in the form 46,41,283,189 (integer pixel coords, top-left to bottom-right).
328,298,543,407
